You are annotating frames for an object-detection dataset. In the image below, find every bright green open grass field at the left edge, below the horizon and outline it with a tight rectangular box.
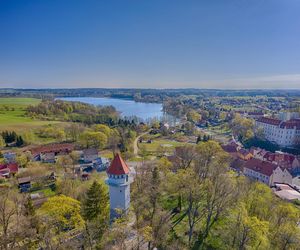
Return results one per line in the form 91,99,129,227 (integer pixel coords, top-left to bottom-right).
0,98,58,132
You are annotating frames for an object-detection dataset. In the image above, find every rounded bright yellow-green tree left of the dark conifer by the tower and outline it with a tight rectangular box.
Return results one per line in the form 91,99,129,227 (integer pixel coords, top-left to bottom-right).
38,195,84,234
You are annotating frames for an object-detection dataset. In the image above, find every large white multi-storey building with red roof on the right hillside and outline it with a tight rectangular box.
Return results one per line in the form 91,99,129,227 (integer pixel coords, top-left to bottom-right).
255,117,300,147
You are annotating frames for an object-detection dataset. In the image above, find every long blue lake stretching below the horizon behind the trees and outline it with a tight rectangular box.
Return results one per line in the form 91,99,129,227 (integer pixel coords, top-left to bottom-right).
57,97,164,121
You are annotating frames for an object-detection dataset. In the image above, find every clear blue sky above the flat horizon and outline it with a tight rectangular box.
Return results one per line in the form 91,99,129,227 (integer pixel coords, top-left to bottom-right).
0,0,300,89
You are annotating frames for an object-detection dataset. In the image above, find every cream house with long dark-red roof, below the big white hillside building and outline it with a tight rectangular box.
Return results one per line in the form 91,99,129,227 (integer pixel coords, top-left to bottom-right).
243,158,293,186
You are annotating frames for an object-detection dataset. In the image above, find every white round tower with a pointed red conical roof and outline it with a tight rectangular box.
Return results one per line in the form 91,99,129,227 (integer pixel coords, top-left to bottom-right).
106,154,131,219
